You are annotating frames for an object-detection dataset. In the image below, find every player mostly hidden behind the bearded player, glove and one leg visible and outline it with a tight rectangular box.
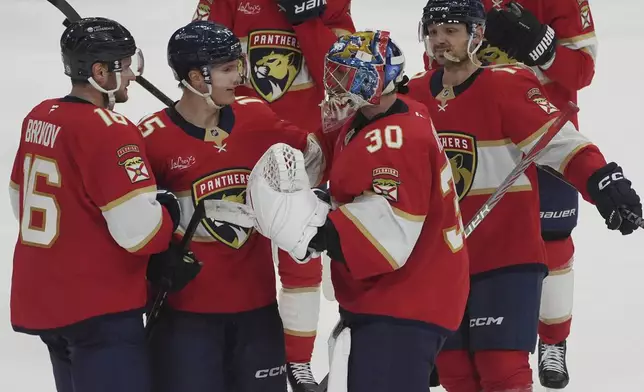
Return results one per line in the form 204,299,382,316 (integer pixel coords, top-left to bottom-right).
424,0,597,389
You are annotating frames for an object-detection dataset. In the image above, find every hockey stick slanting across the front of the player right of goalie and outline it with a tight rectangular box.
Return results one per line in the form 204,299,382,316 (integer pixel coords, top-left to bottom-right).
318,102,579,392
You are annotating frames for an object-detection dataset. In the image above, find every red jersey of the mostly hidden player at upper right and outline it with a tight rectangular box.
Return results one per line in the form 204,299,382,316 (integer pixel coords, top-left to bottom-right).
425,0,597,126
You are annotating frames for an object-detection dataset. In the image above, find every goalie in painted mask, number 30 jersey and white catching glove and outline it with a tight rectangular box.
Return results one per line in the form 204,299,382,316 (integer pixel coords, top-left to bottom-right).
219,31,469,392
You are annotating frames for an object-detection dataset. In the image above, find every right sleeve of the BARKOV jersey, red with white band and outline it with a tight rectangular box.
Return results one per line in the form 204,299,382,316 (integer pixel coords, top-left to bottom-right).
76,108,172,254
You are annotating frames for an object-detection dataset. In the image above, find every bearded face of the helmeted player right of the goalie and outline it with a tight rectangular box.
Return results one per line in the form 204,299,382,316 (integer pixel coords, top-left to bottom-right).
427,23,470,65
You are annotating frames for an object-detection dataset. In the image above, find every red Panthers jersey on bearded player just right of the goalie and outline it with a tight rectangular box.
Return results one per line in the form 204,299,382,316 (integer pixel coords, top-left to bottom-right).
409,67,606,274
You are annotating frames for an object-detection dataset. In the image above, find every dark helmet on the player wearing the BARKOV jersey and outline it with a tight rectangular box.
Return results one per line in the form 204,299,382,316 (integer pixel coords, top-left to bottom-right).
60,18,137,81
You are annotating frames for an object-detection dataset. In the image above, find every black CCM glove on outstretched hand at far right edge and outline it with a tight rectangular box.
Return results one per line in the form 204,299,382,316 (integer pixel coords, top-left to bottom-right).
587,162,642,235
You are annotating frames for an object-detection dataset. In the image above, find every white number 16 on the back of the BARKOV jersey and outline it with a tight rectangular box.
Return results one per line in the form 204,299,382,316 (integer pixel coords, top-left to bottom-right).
20,154,62,248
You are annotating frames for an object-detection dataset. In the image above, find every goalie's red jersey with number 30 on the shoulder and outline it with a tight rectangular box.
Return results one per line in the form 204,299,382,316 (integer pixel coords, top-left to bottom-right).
328,98,469,330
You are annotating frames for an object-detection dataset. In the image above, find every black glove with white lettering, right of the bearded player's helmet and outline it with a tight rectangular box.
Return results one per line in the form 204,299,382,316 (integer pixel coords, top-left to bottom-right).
485,2,557,68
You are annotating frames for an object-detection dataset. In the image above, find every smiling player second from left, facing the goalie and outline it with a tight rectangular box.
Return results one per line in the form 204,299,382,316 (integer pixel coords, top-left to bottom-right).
139,21,325,392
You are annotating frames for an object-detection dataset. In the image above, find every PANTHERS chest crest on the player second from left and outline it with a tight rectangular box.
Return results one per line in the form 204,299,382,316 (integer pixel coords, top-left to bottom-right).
192,168,254,249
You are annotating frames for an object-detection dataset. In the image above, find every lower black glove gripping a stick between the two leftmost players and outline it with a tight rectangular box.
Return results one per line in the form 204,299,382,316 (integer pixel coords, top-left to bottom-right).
147,243,202,292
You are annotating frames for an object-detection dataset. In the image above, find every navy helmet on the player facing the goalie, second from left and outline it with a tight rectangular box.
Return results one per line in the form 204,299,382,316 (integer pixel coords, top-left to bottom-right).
168,20,245,83
